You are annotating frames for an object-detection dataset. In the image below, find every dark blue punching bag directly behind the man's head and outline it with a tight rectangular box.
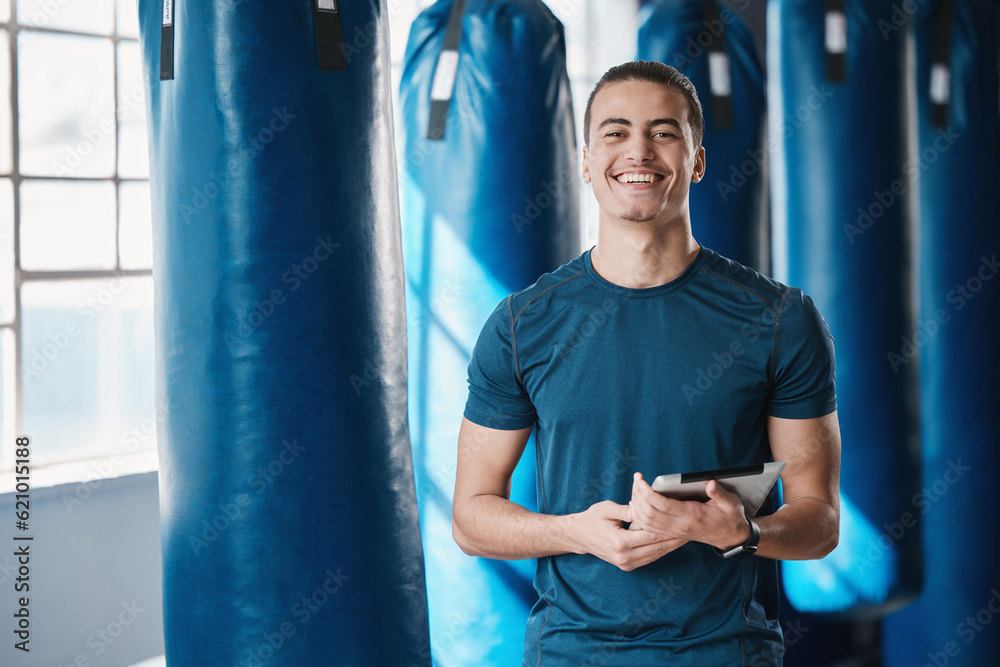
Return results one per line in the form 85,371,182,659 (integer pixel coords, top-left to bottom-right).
638,0,770,272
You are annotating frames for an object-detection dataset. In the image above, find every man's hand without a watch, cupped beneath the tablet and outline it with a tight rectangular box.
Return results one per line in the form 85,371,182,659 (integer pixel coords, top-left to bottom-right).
570,500,687,572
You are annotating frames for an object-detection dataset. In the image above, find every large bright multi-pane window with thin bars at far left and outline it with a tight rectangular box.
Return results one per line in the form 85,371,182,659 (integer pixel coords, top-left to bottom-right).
0,0,156,482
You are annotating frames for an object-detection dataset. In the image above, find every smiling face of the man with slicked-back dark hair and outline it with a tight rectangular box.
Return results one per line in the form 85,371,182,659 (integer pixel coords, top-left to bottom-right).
583,81,705,227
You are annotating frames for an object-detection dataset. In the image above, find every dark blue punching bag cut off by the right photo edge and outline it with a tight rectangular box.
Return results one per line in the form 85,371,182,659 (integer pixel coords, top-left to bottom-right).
883,0,1000,667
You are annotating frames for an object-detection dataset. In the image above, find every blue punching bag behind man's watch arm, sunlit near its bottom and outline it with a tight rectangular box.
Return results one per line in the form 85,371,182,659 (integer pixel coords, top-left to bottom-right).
768,0,921,618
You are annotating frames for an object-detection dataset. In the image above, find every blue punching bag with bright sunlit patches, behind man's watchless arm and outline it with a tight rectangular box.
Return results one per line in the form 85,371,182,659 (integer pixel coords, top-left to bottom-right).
400,0,580,667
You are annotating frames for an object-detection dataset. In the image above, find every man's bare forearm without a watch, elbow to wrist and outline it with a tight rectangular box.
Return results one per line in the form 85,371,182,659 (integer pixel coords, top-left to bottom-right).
452,495,579,560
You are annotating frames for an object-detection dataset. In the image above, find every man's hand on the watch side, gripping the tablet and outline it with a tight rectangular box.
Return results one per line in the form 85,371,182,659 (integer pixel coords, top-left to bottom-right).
629,472,750,549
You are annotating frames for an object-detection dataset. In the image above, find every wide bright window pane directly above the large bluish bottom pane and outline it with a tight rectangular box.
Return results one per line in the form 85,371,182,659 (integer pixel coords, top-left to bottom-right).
20,180,115,271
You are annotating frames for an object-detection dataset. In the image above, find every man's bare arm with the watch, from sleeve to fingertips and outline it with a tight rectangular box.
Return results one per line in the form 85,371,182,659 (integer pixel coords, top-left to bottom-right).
630,411,840,560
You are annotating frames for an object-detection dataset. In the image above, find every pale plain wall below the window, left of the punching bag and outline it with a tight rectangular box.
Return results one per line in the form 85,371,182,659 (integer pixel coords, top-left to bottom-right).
0,472,163,667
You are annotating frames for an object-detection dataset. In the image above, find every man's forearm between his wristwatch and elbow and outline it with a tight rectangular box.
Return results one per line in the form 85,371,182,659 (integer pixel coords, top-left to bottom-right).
754,497,840,560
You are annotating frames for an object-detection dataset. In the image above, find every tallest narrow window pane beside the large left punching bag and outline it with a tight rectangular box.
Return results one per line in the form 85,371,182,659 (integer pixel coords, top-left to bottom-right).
115,42,149,178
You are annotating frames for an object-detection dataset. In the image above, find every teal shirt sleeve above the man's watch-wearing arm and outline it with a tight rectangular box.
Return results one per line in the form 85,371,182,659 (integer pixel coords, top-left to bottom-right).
768,288,837,419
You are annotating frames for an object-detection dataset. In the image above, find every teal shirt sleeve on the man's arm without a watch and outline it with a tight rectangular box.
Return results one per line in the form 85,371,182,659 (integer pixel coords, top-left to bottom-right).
465,297,535,431
